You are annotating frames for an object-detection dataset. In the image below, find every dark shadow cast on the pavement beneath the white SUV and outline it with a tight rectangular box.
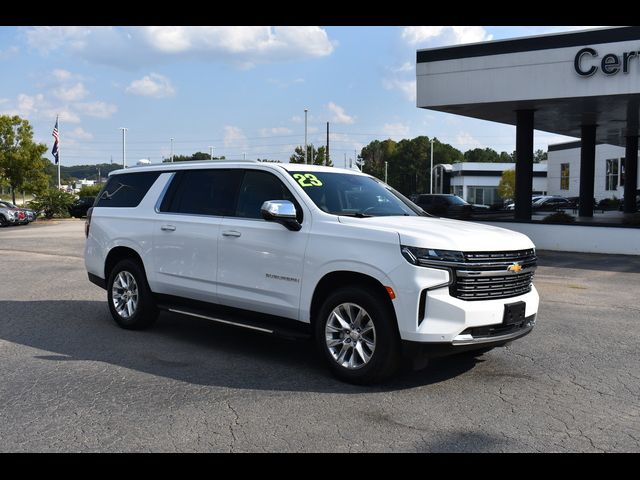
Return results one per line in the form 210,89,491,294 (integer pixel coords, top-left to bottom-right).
0,300,477,394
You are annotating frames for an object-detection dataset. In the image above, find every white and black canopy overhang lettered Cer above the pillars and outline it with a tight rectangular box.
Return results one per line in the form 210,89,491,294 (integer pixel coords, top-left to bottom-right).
416,27,640,146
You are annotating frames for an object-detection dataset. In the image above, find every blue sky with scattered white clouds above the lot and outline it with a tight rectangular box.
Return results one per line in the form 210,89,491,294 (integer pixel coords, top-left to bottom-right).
0,26,600,166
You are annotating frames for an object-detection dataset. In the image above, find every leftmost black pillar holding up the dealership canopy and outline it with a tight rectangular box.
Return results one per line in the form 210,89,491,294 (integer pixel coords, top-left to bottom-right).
515,110,533,220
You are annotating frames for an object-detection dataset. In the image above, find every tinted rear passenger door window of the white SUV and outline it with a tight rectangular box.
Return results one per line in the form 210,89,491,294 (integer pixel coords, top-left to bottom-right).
160,169,242,217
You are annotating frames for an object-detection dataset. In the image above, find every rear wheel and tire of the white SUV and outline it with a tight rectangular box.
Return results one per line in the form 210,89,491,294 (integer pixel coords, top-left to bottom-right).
107,258,158,330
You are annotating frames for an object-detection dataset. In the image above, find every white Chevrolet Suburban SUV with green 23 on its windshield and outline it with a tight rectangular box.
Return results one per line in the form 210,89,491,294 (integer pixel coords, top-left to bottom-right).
85,161,539,384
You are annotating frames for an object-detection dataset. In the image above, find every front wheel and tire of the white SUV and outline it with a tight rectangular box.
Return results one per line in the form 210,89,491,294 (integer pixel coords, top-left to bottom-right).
314,287,400,385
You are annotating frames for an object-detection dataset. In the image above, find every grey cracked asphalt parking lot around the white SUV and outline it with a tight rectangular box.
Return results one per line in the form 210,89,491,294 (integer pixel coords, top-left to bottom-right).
0,220,640,452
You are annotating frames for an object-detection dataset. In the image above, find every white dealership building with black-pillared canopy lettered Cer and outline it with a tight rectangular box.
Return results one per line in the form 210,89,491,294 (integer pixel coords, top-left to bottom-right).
416,26,640,253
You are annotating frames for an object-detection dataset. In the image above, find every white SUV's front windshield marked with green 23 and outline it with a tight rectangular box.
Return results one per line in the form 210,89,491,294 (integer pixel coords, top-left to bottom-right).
289,172,423,217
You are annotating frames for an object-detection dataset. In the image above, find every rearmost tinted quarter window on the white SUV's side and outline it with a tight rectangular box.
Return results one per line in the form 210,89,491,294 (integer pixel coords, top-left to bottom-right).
95,172,160,207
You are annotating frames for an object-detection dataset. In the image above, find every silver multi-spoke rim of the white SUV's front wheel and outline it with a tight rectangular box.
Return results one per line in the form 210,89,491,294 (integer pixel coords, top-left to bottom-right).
325,303,376,370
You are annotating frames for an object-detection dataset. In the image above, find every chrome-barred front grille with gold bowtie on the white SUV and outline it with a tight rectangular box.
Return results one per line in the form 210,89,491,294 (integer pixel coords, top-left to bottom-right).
450,249,537,300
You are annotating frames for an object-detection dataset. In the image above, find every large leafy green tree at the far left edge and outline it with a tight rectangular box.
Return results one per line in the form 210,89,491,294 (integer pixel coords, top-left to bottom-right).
0,115,49,203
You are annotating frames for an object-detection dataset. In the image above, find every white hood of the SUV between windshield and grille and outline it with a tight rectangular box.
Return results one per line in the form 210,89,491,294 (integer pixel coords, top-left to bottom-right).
339,216,535,252
